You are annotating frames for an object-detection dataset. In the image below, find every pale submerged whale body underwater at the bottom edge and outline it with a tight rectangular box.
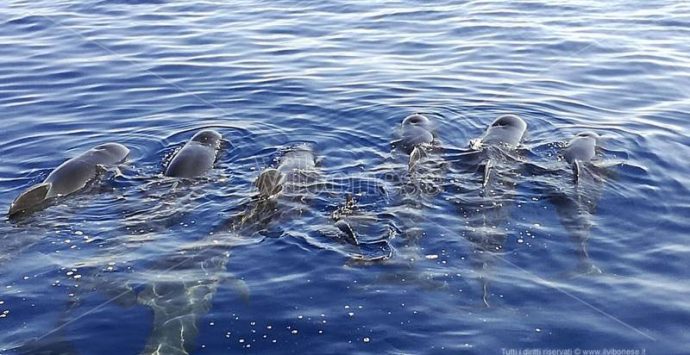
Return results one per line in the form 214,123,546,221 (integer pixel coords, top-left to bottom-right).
136,241,249,355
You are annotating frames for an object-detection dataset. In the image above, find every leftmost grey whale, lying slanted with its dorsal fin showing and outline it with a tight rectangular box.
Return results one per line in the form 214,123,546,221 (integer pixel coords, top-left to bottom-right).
8,143,129,217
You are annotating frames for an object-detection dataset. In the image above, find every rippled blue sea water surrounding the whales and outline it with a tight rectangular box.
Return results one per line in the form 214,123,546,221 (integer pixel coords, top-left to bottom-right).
0,0,690,354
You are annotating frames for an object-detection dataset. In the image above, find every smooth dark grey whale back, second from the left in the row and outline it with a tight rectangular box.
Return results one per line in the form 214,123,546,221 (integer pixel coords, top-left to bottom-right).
165,130,223,178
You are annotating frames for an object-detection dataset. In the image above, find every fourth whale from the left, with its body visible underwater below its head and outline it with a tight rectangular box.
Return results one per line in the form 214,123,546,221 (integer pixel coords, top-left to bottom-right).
360,113,447,287
